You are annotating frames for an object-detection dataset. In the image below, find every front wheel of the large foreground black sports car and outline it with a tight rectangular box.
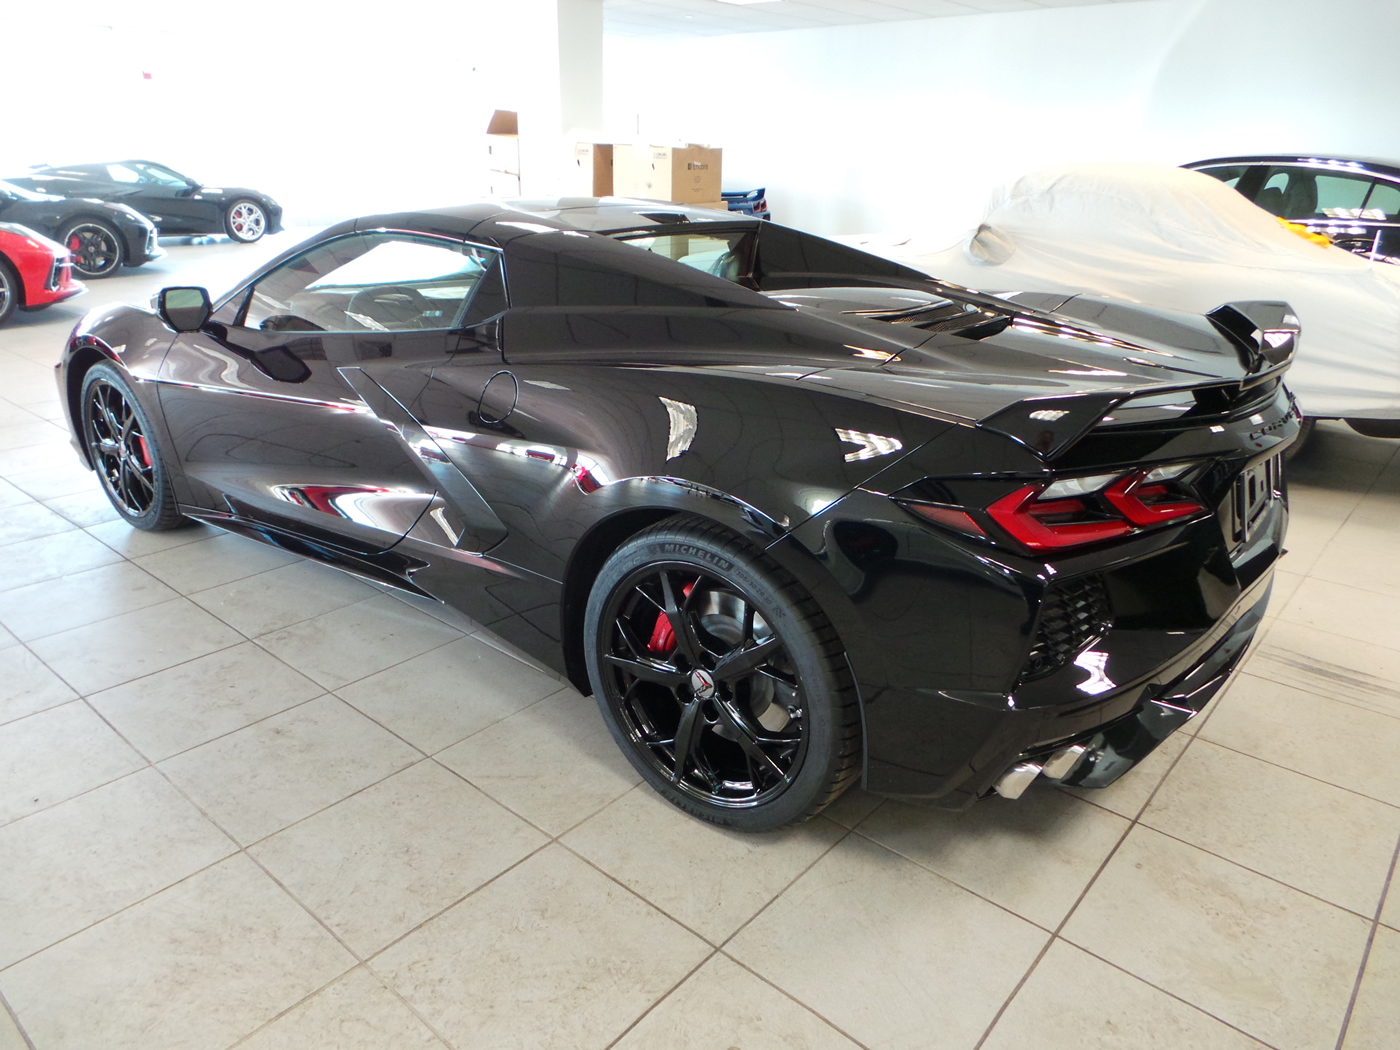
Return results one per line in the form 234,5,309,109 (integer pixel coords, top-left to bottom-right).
81,364,188,532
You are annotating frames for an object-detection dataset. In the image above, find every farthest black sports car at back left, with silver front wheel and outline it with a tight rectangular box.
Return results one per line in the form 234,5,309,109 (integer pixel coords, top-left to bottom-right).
11,161,281,244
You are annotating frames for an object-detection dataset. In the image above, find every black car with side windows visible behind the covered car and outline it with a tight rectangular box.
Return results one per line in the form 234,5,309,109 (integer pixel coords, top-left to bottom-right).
1182,154,1400,263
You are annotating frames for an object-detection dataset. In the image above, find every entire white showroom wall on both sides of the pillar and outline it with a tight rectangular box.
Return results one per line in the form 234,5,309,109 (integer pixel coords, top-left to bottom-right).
0,0,1400,237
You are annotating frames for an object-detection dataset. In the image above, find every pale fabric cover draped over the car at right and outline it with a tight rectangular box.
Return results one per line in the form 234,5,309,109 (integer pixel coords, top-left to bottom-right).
873,164,1400,419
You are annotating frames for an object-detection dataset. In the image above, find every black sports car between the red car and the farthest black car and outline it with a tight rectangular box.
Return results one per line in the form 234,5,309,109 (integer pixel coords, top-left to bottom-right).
0,182,165,280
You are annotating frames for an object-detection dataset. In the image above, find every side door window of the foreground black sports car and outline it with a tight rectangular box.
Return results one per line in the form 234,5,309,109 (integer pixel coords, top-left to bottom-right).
241,234,496,332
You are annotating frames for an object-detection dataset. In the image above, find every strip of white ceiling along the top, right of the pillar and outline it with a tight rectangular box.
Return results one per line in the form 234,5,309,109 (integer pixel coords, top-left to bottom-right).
603,0,1134,36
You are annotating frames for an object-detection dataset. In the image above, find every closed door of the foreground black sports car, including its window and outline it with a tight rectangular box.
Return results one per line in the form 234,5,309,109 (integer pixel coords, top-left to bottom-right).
160,231,504,552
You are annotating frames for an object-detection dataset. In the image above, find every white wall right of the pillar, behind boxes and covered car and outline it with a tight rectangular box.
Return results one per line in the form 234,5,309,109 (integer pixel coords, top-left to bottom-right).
606,0,1400,238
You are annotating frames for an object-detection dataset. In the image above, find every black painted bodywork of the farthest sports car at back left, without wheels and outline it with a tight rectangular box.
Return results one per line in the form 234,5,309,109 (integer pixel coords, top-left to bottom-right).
11,161,281,235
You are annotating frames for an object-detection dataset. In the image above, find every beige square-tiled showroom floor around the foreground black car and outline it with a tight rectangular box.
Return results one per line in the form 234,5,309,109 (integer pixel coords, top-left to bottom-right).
0,237,1400,1050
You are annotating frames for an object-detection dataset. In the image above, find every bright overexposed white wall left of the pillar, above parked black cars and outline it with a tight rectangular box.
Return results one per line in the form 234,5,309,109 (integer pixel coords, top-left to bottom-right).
0,0,560,224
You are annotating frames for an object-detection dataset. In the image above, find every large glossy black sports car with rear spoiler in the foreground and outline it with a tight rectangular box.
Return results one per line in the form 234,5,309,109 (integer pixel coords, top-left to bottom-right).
57,200,1298,830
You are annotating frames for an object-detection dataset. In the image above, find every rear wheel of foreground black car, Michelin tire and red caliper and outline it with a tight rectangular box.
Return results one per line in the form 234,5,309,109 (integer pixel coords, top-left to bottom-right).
584,517,861,832
